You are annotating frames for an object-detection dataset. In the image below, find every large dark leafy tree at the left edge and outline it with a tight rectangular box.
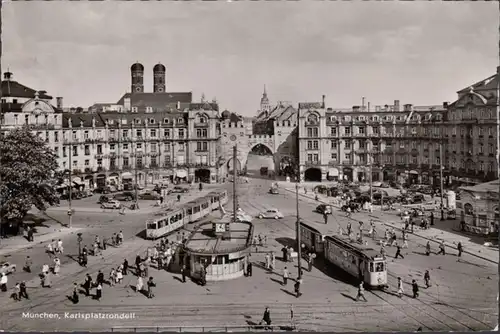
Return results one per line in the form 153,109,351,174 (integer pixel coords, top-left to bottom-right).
0,127,59,226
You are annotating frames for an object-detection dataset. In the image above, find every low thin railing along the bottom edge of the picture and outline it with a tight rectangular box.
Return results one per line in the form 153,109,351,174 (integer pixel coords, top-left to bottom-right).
111,324,297,333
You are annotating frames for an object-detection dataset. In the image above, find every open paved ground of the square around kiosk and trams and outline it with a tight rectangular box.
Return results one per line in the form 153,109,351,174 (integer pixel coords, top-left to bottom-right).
0,179,498,331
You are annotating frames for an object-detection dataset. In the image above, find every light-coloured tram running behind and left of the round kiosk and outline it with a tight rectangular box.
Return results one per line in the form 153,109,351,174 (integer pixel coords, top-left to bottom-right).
146,190,228,240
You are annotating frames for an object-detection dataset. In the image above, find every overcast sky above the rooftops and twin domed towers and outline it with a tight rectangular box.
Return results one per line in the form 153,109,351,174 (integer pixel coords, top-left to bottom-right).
2,1,499,115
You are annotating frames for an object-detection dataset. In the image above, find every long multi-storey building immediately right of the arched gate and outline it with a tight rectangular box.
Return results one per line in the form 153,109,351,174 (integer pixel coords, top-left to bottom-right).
299,101,445,183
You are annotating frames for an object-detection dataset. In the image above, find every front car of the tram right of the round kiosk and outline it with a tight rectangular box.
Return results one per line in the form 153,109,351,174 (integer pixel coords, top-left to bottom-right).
323,236,387,289
